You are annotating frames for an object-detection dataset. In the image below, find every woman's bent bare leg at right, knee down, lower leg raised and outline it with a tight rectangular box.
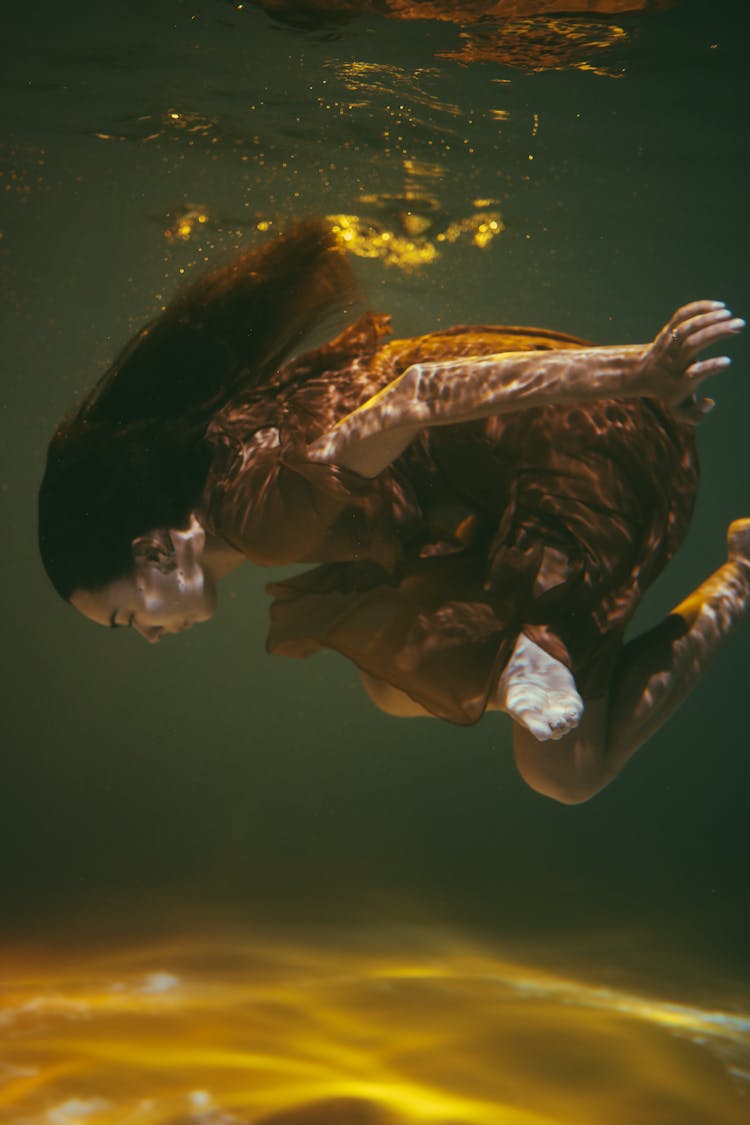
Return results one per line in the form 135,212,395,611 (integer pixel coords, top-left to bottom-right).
514,520,750,804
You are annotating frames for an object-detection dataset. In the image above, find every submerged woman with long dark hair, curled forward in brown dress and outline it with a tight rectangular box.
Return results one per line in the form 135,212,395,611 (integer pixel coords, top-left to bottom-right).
39,222,750,802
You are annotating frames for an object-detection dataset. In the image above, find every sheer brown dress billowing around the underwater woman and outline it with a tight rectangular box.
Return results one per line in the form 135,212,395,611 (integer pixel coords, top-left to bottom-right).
204,314,697,723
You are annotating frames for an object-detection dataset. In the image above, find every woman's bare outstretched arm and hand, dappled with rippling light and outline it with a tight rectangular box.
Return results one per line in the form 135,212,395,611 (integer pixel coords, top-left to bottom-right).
308,300,744,477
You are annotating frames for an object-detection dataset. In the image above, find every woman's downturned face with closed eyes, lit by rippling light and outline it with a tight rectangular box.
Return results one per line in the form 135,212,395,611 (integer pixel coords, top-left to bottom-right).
71,532,217,644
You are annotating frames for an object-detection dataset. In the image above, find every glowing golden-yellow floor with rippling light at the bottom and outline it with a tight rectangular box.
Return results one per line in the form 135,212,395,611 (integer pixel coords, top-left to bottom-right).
0,936,750,1125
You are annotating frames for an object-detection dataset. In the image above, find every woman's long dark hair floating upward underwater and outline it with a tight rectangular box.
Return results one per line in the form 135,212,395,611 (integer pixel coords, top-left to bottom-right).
38,219,355,600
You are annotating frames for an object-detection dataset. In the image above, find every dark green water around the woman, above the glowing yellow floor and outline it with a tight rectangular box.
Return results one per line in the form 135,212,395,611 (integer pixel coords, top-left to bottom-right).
0,0,750,1122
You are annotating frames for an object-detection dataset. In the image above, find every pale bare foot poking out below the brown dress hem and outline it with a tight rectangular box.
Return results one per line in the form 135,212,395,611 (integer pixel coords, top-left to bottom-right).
495,633,584,743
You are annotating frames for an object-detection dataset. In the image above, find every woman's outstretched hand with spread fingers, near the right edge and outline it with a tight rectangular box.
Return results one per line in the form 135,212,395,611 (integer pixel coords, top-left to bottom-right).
640,300,744,422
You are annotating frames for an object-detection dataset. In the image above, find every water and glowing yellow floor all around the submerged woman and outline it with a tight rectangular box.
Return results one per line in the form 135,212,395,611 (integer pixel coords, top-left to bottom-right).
0,0,750,1125
